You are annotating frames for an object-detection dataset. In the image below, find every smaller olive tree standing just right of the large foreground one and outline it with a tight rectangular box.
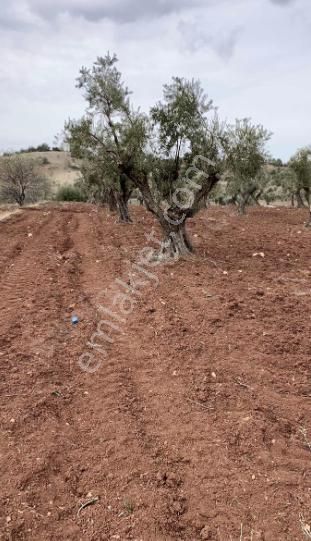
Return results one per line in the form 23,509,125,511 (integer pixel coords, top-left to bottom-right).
226,119,271,214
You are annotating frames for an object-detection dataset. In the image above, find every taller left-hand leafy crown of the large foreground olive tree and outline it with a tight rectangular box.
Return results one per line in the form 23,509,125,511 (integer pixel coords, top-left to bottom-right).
65,53,148,194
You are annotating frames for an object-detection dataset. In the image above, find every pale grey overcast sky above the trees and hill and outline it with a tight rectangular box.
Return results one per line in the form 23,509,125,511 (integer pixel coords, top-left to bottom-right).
0,0,311,159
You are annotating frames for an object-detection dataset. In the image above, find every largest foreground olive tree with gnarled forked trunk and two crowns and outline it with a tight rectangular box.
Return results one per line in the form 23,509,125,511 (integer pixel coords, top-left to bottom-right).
66,54,224,257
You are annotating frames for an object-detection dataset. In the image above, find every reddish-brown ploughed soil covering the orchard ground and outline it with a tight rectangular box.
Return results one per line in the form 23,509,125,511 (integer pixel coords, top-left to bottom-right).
0,205,311,541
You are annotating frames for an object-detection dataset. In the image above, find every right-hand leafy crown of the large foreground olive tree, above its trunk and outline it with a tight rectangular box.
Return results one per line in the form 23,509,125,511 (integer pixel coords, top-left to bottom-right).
150,77,224,205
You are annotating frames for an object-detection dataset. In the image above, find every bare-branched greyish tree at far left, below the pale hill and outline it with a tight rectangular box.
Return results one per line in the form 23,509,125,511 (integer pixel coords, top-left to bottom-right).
0,154,50,207
